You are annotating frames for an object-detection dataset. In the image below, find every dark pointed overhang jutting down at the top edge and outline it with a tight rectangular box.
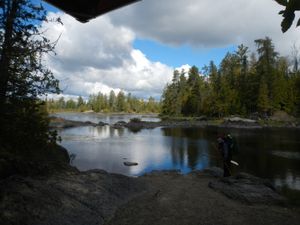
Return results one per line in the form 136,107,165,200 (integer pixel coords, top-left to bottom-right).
44,0,141,23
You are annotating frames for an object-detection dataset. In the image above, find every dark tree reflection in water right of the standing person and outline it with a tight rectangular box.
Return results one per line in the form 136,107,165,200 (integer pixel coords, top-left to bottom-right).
236,129,300,185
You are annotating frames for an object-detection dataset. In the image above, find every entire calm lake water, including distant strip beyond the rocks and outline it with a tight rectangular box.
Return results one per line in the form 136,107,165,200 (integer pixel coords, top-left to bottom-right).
57,113,300,203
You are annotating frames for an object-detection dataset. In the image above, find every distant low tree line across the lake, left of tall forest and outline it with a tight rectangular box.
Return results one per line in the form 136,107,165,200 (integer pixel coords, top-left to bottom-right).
47,90,160,113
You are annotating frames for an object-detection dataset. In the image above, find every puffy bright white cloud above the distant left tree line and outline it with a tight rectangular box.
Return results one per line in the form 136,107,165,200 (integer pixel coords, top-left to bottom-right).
44,14,173,98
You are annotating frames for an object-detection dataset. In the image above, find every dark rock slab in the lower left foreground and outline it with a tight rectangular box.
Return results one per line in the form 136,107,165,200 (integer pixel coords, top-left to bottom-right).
0,170,144,225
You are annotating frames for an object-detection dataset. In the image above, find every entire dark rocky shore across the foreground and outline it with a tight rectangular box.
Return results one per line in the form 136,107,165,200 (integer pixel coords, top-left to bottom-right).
0,169,300,225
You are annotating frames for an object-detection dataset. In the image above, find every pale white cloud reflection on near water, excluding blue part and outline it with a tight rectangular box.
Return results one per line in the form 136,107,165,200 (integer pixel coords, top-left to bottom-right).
62,127,168,175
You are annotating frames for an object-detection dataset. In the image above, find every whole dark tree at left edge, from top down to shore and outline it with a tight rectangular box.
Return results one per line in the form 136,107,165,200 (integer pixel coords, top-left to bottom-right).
0,0,65,174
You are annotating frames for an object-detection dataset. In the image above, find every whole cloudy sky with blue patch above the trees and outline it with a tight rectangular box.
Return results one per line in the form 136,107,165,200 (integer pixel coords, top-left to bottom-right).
43,0,300,99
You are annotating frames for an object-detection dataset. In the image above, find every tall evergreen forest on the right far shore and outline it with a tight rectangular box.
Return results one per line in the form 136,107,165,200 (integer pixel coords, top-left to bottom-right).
161,37,300,118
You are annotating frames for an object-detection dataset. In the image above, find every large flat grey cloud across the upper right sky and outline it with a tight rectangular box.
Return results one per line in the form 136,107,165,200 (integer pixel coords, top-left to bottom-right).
109,0,300,54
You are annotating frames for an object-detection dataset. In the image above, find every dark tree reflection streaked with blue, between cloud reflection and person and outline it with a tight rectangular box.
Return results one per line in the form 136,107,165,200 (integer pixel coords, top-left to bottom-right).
162,128,209,170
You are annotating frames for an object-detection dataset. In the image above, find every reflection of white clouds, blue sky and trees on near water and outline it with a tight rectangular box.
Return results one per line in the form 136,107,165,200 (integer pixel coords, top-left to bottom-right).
60,126,216,175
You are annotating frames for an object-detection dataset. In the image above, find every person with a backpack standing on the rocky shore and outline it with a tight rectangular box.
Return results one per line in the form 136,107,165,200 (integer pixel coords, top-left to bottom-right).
217,137,232,177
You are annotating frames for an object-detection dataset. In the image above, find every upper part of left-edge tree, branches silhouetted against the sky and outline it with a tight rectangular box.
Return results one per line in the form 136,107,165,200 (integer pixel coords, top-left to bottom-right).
0,0,59,100
